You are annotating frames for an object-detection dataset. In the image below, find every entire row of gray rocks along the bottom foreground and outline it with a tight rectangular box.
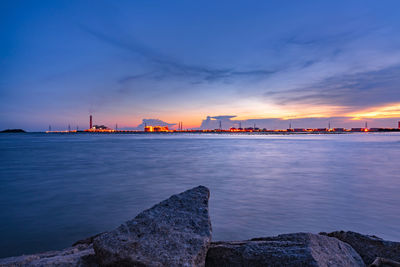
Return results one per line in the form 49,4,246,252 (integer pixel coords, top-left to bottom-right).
0,186,400,267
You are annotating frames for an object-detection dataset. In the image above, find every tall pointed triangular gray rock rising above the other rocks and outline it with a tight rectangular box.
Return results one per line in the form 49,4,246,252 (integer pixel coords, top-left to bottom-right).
93,186,211,266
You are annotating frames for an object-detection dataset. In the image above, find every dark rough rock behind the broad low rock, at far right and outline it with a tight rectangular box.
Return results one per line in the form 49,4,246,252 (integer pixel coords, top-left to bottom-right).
320,231,400,265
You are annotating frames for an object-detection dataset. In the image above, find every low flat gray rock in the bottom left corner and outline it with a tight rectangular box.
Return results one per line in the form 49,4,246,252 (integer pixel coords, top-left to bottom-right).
0,245,98,267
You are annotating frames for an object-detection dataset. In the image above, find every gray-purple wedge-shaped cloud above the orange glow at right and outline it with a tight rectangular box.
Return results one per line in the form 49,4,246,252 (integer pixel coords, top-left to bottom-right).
264,65,400,108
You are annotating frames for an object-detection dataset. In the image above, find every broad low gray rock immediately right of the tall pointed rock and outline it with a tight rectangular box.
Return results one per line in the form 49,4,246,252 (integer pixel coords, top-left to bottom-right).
206,233,365,267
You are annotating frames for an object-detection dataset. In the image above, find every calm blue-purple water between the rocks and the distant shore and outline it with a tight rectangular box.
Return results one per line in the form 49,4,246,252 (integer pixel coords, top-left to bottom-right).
0,133,400,257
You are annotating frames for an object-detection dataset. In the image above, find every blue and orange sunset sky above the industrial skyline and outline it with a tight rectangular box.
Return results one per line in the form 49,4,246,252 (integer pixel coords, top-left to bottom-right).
0,0,400,131
